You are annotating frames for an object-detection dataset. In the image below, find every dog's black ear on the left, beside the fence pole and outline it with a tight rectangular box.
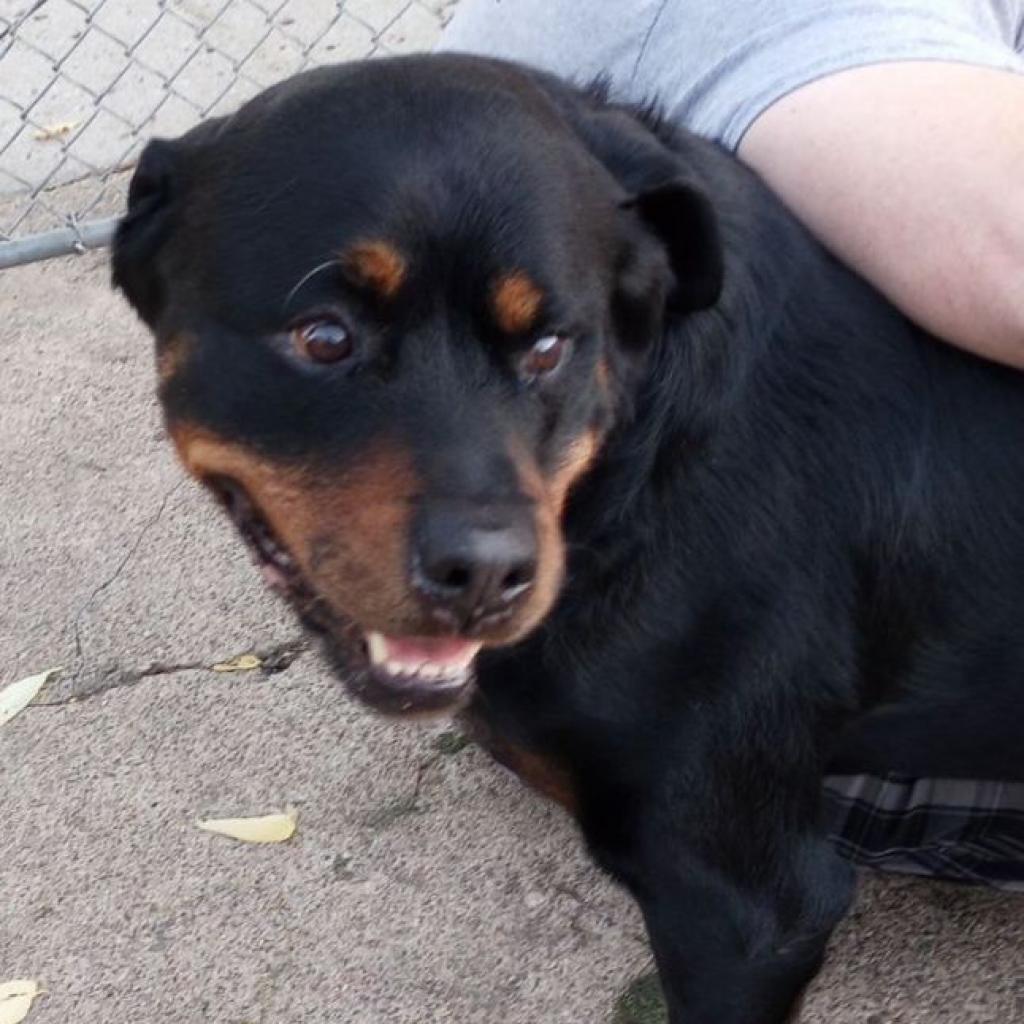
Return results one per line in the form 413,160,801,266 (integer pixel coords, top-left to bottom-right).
112,139,182,327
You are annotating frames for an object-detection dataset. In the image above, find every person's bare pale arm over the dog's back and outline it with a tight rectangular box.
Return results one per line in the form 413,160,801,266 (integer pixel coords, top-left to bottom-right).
739,61,1024,369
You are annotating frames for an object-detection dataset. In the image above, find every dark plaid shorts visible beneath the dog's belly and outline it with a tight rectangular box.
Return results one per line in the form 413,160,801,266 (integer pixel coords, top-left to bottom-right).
824,775,1024,892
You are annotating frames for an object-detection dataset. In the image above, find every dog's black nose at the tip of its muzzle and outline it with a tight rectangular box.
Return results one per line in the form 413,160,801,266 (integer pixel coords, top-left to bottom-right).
413,502,537,628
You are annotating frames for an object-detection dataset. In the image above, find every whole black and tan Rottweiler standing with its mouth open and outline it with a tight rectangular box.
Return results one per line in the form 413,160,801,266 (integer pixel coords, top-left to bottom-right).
114,56,1024,1024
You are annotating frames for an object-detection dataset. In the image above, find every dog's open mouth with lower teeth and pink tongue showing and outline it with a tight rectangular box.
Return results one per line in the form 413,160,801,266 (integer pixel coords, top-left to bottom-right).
206,477,483,714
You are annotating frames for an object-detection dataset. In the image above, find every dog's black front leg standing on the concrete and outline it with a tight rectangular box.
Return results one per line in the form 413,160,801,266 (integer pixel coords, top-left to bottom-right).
581,716,853,1024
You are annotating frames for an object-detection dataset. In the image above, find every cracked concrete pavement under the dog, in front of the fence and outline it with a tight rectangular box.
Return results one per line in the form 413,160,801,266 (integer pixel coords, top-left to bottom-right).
0,254,1024,1024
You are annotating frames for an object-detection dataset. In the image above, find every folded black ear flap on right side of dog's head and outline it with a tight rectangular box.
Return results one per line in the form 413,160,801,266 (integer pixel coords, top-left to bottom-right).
623,179,725,313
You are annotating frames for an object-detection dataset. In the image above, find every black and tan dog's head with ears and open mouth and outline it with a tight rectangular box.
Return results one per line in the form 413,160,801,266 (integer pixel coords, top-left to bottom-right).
114,56,721,711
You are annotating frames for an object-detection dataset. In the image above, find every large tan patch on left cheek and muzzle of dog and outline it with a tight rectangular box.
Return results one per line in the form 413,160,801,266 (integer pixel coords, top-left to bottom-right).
170,424,420,632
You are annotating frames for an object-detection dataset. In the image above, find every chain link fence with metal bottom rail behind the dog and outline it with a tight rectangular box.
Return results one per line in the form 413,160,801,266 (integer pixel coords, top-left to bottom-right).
0,0,459,267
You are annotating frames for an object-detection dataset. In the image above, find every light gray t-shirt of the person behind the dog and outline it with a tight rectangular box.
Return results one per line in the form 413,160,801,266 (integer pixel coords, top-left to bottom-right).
439,0,1024,148
